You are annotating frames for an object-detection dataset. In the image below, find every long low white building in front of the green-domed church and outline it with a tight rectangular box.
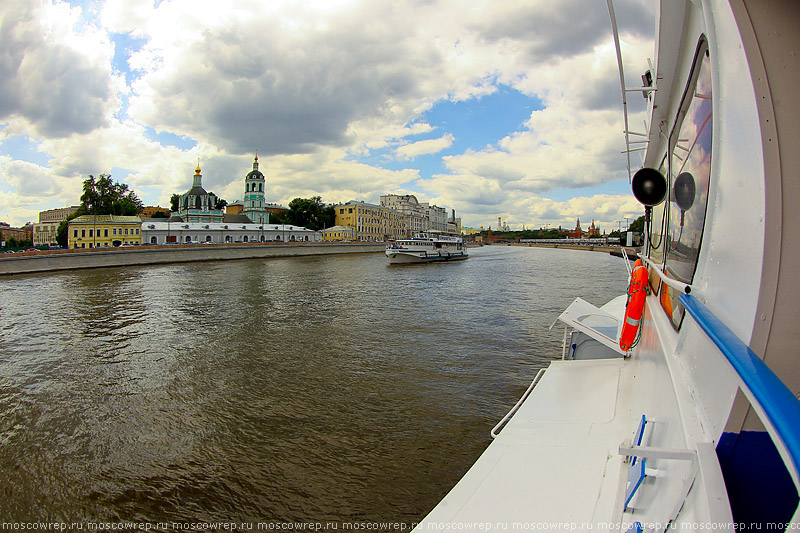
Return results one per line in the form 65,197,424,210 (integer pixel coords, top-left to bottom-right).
142,219,322,245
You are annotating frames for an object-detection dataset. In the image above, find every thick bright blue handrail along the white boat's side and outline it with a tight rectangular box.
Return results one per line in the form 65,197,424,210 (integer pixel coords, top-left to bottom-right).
678,294,800,489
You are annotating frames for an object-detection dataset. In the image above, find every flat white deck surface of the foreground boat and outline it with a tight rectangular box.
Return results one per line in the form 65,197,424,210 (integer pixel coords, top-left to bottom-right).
417,359,636,531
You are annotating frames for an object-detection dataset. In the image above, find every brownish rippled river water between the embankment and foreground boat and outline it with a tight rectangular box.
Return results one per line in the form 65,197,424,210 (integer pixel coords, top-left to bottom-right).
0,246,626,525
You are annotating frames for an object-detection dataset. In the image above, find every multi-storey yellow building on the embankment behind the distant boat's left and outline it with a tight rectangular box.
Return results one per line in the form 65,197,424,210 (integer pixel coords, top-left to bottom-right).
335,201,408,241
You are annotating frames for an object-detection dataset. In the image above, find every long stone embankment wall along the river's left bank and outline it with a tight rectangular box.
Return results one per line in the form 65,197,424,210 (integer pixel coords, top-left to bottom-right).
0,243,385,276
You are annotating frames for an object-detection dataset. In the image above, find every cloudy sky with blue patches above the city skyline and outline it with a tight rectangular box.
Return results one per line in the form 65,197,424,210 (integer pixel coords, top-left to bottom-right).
0,0,654,230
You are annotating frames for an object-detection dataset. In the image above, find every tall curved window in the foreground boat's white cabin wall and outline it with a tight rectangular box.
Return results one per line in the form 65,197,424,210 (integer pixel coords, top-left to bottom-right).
661,38,712,329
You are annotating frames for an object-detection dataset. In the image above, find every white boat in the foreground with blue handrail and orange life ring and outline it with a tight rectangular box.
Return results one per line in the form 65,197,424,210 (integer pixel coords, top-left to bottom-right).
417,0,800,532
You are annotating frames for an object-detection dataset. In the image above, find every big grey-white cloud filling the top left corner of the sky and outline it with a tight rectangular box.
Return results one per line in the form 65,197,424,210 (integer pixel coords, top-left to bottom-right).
0,0,115,137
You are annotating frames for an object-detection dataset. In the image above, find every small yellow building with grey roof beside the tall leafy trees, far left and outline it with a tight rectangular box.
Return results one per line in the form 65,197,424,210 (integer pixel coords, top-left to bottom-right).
68,215,142,248
